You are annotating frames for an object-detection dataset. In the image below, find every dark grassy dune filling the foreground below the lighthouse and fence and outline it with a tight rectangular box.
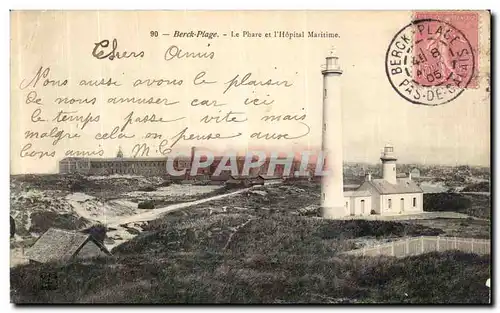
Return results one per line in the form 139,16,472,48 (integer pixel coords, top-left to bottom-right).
11,207,484,303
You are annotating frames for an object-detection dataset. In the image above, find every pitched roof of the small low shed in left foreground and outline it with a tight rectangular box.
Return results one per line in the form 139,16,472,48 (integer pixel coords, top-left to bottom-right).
25,228,111,263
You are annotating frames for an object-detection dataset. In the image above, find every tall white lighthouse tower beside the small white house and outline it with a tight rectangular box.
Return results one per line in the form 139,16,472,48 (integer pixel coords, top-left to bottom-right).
321,53,348,218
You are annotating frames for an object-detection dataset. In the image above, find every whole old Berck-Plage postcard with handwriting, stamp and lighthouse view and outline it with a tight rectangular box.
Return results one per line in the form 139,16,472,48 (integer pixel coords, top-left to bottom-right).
10,10,492,304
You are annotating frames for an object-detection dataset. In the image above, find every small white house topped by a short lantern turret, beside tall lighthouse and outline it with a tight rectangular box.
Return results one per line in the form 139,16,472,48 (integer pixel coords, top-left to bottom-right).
357,145,423,215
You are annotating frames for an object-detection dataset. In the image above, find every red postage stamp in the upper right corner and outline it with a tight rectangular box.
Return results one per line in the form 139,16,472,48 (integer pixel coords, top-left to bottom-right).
413,11,479,88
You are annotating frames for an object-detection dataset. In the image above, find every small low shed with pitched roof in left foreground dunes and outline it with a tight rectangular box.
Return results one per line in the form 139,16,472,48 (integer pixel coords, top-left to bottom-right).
25,228,111,263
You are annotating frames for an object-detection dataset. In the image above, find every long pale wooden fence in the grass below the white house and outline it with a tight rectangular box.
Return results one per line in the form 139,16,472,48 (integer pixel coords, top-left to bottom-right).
346,236,491,258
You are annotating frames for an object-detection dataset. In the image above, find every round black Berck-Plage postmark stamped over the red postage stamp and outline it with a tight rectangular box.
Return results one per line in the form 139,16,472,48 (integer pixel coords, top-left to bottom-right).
385,19,475,106
